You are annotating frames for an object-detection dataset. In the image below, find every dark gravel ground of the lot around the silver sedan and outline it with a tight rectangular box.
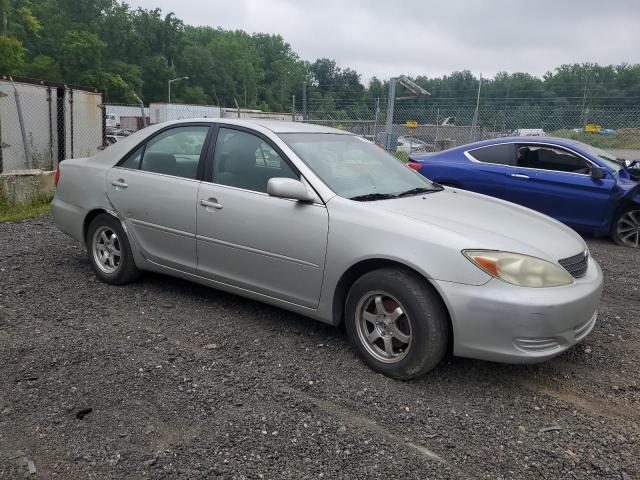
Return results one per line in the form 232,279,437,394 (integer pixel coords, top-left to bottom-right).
0,217,640,480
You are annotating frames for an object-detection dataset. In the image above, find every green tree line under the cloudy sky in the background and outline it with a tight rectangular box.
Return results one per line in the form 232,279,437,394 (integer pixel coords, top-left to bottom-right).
0,0,640,115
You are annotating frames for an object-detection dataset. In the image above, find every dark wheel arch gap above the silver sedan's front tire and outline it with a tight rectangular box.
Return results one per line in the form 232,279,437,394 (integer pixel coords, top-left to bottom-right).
332,258,454,351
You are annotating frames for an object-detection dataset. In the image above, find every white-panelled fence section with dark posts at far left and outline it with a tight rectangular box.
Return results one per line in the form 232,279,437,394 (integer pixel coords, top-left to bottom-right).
0,77,106,173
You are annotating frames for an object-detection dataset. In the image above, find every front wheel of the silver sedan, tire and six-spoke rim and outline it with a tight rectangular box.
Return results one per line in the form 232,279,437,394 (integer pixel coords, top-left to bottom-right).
345,268,449,380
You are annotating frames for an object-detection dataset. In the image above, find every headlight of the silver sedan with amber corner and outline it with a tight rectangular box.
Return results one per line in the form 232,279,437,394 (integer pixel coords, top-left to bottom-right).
462,250,573,288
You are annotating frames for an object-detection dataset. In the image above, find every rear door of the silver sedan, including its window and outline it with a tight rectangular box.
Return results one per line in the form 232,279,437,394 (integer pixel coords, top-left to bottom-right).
106,124,209,273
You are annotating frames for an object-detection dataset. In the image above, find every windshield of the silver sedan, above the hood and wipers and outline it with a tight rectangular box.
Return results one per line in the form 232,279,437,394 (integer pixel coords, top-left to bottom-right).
280,133,442,201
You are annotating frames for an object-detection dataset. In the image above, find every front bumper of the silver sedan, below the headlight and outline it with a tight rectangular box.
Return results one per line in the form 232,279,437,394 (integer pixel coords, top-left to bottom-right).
435,258,602,363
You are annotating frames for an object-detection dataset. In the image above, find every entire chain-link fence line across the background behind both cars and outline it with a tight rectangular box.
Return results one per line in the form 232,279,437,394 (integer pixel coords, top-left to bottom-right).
0,77,640,173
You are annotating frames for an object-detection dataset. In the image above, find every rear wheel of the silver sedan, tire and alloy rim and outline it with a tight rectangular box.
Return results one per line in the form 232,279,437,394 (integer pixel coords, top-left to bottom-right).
87,213,141,285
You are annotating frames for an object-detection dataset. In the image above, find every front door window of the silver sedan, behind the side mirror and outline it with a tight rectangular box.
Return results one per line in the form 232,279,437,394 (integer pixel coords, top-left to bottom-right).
213,128,299,193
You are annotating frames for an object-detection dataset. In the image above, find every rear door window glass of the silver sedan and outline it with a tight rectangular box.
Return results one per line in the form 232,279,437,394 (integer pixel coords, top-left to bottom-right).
125,126,209,179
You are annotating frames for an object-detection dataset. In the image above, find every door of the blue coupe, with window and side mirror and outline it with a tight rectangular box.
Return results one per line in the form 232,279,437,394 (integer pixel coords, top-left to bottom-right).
507,143,615,230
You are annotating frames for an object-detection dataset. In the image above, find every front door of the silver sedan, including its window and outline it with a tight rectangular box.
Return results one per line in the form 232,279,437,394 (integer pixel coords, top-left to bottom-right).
197,127,328,308
